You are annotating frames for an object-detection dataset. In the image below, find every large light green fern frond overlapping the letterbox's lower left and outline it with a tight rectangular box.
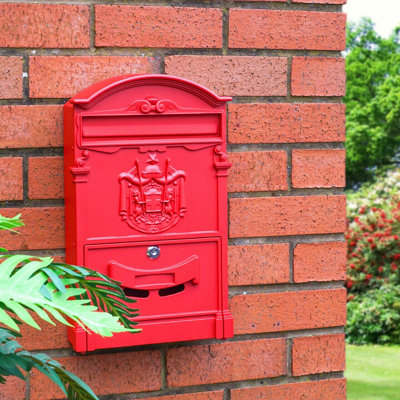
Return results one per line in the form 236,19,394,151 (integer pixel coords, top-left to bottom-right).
0,255,137,336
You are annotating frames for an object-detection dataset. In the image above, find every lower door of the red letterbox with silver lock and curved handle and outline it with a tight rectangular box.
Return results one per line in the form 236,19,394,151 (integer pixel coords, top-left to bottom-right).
85,237,221,318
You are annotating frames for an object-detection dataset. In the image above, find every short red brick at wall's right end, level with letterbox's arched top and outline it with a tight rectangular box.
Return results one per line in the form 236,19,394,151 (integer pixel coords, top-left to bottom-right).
291,57,346,96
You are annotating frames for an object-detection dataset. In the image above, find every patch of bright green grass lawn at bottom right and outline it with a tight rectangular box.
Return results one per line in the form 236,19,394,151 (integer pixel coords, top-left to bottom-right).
346,345,400,400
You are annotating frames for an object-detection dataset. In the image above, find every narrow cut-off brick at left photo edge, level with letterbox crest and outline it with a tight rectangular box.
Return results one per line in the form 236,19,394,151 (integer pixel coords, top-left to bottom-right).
0,157,23,201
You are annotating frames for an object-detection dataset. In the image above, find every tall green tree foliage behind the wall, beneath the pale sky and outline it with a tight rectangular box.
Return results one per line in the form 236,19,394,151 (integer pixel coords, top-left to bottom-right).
344,19,400,187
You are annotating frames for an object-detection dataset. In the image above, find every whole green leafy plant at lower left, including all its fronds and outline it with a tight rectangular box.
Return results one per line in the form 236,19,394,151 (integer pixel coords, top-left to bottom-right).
0,215,138,400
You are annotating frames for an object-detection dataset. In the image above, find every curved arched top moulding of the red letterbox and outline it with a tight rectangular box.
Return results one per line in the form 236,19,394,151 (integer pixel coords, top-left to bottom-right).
70,75,232,109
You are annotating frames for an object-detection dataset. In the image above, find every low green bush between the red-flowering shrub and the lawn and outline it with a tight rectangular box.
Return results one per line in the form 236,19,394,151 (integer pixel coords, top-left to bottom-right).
346,284,400,345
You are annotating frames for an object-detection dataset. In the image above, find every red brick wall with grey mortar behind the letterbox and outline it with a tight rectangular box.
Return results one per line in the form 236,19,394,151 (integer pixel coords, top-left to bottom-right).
0,0,346,400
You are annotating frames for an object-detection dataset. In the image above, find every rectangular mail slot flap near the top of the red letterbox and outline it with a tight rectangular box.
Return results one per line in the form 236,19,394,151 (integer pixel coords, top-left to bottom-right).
81,113,221,147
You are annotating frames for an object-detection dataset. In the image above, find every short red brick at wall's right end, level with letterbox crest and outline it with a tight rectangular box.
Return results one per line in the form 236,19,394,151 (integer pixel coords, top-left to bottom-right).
292,149,346,188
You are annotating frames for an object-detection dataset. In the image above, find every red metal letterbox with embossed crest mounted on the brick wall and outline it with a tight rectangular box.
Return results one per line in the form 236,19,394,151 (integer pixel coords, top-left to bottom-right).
64,75,233,352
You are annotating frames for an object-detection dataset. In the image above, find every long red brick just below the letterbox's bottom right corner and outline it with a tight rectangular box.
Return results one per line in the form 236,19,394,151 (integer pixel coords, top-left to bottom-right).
167,339,286,386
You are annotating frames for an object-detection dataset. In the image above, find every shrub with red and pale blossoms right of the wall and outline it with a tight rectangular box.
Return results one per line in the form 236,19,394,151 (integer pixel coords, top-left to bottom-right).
345,170,400,300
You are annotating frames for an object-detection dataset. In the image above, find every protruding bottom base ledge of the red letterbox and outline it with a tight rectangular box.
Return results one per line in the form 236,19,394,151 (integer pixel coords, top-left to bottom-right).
68,311,233,353
